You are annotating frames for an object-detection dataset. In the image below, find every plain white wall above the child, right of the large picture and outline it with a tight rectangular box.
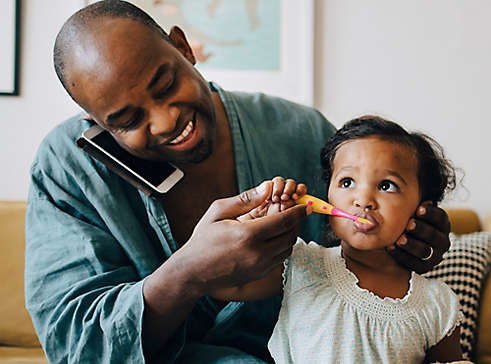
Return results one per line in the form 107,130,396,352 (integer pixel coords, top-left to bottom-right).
314,0,491,223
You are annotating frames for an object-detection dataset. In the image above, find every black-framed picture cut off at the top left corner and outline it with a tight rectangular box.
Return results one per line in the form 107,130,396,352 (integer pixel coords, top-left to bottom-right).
0,0,20,95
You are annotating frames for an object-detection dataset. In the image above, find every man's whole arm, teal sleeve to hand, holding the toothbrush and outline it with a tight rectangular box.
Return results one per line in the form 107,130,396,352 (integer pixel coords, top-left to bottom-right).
26,157,305,363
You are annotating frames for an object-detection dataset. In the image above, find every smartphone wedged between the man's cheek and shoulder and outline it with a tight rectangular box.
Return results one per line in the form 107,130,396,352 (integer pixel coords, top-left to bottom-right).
77,125,184,198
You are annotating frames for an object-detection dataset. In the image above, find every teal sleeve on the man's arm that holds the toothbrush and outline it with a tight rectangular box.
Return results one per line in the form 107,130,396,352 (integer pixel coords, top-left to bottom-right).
25,156,184,363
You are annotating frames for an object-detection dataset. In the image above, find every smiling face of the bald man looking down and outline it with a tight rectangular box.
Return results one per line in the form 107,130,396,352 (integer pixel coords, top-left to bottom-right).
66,18,216,163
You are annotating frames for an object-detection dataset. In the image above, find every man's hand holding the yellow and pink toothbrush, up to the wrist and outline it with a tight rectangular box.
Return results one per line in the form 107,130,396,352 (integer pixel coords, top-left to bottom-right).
176,181,311,295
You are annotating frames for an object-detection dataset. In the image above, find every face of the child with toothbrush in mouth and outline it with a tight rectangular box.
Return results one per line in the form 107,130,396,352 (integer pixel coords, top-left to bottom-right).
328,137,420,250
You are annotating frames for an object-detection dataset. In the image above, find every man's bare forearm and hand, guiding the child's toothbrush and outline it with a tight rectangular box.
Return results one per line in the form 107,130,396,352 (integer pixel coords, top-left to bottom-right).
143,182,307,357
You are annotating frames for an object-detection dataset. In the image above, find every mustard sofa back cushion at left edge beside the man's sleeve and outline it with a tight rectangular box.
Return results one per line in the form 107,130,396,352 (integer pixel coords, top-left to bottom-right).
0,201,39,347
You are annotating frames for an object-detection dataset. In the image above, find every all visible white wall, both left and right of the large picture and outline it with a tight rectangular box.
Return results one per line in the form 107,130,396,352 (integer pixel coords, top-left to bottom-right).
0,0,491,222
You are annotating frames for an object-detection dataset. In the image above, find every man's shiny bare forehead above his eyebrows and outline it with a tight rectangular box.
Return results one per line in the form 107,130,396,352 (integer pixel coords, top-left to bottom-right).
63,18,177,112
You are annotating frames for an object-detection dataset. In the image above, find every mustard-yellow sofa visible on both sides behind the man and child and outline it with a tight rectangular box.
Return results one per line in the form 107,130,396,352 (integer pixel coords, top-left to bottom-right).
0,201,491,364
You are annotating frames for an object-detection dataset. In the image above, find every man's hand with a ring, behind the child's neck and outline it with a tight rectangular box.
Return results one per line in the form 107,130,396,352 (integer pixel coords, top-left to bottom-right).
387,202,450,273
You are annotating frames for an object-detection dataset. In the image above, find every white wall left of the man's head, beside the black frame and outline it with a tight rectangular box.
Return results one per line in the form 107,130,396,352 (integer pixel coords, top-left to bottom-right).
0,0,83,200
